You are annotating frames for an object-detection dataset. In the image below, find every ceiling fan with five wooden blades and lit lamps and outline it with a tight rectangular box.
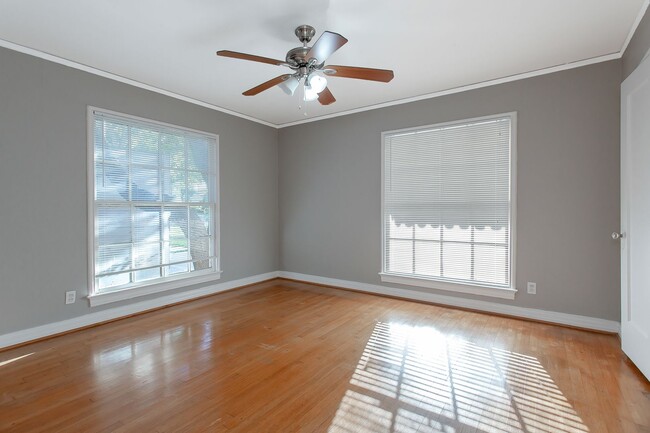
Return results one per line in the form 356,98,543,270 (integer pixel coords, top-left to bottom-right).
217,24,393,105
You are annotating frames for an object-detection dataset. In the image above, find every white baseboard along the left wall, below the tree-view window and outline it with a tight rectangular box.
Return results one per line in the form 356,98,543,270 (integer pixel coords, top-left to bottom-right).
0,271,279,348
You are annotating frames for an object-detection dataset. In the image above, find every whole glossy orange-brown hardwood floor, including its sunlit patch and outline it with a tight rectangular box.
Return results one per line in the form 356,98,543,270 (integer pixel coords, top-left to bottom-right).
0,280,650,433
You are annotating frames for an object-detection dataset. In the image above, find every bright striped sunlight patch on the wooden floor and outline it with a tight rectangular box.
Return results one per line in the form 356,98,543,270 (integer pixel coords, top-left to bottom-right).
328,322,589,433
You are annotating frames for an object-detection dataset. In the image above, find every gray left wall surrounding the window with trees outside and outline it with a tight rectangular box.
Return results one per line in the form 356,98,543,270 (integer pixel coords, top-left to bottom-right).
0,48,279,334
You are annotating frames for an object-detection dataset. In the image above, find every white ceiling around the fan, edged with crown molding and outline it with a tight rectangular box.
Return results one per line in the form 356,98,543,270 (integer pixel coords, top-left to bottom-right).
0,0,647,126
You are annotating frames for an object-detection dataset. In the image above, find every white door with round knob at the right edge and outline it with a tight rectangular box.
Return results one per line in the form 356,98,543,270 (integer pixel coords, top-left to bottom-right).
613,53,650,378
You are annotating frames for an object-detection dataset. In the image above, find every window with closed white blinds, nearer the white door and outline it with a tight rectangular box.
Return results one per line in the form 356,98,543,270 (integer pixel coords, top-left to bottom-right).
381,113,516,299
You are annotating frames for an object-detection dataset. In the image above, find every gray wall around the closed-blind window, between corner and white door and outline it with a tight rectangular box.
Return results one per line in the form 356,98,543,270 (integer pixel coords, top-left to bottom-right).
279,60,621,320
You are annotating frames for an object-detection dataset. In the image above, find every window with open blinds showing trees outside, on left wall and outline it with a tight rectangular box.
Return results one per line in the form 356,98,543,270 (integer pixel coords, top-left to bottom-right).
89,108,219,304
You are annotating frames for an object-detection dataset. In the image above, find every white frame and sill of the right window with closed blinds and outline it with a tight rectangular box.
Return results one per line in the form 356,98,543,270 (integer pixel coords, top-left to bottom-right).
379,112,517,299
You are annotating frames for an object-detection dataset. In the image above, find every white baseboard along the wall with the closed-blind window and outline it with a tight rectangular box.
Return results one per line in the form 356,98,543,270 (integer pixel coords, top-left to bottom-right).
279,271,620,334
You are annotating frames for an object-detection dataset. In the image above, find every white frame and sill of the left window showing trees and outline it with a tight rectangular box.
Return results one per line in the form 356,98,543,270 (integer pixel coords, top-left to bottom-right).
86,106,222,307
